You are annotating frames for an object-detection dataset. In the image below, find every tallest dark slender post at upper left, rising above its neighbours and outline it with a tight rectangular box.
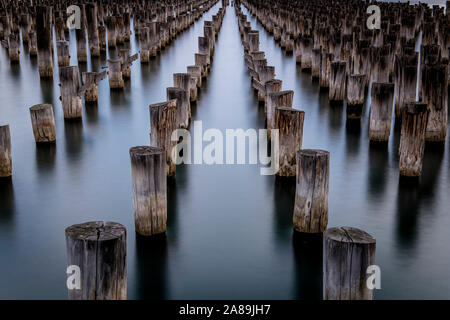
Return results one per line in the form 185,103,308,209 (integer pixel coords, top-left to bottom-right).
36,6,53,78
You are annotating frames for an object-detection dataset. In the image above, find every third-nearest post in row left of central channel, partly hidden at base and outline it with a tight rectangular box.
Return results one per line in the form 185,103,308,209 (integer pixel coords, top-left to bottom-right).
149,99,177,176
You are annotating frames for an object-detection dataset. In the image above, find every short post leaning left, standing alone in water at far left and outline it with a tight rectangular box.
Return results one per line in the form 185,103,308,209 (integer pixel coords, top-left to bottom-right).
30,104,56,143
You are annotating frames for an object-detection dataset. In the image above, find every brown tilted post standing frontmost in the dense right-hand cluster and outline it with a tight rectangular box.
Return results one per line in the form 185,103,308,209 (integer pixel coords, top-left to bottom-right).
399,102,428,177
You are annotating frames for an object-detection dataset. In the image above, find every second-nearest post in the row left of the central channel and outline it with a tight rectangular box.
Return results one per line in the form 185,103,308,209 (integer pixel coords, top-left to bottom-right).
130,146,167,236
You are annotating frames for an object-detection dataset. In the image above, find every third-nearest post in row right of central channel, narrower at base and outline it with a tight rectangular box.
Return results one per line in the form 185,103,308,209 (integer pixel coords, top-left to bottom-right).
275,107,305,177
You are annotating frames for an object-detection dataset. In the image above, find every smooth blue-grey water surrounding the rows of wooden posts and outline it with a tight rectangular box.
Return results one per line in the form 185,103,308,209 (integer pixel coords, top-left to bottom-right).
0,4,450,299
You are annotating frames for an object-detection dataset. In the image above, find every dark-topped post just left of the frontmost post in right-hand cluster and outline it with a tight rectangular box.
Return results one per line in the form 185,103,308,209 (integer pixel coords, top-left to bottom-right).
369,82,394,142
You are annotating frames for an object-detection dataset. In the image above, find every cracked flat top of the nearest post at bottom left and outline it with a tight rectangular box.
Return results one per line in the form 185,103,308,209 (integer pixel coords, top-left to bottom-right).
66,221,126,241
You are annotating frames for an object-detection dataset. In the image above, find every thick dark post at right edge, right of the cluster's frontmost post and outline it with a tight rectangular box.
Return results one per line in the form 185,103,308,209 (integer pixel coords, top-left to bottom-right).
422,64,448,143
